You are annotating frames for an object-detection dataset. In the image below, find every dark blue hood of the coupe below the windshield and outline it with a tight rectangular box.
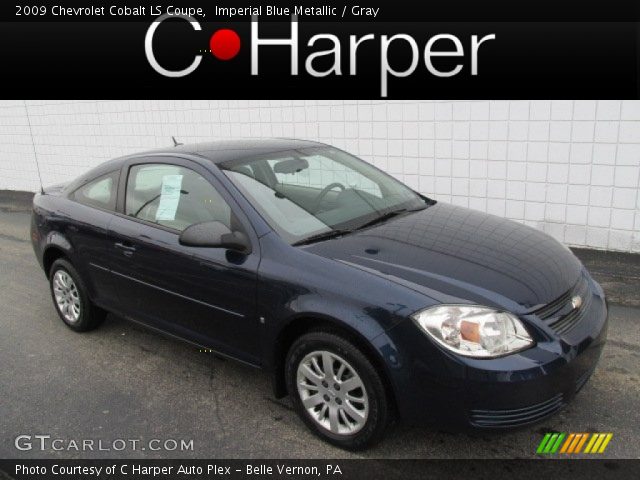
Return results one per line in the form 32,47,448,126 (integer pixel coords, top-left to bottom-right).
307,203,582,312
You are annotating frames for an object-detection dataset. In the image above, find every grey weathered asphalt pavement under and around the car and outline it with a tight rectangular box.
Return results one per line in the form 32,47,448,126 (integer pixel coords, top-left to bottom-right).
0,209,640,458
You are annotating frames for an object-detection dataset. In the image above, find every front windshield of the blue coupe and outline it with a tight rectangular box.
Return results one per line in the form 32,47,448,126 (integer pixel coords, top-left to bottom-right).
220,147,427,244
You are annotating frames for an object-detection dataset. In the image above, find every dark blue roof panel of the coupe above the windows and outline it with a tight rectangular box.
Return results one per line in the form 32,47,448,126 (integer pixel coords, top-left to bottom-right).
134,138,325,164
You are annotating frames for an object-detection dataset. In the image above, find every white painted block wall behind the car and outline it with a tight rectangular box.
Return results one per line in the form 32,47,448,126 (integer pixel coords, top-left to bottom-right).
0,101,640,252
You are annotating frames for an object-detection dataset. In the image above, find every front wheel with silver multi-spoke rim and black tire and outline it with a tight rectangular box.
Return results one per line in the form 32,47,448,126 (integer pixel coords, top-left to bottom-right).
285,332,390,450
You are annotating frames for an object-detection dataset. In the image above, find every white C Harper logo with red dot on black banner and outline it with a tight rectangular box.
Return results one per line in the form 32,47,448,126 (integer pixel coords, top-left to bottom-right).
144,14,496,97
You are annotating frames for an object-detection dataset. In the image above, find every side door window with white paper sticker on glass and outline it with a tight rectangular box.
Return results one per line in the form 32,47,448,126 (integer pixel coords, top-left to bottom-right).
125,163,231,231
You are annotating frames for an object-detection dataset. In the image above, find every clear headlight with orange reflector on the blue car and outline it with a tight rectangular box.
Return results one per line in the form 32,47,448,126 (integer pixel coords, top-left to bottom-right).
411,305,533,358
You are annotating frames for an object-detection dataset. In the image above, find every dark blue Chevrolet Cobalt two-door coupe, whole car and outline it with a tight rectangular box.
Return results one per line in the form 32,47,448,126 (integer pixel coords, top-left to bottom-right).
32,139,607,449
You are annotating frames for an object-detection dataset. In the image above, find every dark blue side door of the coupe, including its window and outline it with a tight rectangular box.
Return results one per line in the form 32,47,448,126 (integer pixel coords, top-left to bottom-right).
109,157,260,363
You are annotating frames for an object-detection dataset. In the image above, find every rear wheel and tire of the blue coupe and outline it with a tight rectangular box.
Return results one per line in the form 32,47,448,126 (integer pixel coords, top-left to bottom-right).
49,258,107,332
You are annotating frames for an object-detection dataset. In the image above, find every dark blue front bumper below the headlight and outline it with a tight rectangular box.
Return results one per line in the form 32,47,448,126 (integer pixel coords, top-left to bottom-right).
388,279,607,429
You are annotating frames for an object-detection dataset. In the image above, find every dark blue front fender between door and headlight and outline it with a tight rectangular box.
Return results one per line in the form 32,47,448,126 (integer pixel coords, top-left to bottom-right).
257,235,433,402
